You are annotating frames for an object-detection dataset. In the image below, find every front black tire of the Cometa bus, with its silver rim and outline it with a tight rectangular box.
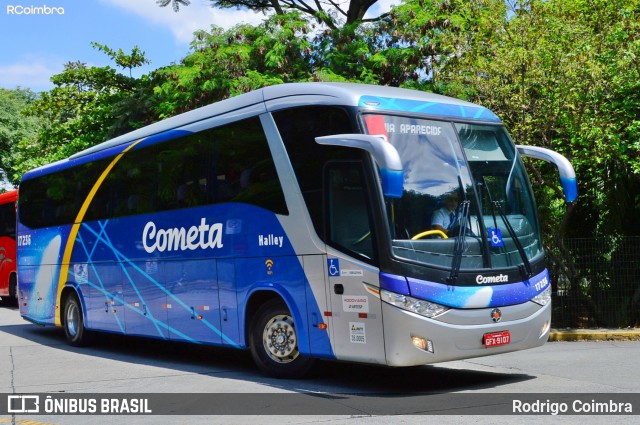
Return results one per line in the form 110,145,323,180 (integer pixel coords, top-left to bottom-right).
250,299,314,378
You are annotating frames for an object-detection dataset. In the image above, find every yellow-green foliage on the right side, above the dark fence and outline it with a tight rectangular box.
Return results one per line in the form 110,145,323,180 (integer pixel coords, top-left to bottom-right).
439,0,640,236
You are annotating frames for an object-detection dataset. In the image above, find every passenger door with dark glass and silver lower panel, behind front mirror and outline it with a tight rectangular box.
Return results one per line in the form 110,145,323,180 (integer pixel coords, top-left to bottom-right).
324,161,385,364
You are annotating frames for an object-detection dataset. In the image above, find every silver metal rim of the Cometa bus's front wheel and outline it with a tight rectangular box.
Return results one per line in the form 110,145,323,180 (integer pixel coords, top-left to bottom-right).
262,315,300,363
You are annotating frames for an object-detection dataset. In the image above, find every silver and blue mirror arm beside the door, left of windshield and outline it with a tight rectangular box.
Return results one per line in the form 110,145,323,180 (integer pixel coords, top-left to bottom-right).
316,134,404,198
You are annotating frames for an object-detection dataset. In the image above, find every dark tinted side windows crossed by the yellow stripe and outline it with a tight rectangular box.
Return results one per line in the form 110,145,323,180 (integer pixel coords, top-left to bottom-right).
20,118,287,227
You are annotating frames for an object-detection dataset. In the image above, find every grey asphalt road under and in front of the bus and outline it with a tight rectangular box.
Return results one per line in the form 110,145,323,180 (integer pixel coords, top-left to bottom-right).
0,300,640,425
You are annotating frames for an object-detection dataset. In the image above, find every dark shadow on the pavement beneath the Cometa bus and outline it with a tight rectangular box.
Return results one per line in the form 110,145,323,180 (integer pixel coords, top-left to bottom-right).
0,316,535,395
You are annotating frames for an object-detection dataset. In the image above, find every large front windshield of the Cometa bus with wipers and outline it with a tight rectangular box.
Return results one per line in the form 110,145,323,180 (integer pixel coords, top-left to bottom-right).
365,115,542,271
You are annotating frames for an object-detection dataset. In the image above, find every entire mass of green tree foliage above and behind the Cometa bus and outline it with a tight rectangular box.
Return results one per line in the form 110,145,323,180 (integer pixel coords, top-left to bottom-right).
6,0,640,242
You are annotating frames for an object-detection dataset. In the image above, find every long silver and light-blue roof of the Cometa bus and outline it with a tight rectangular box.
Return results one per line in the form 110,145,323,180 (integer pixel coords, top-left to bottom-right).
20,83,500,178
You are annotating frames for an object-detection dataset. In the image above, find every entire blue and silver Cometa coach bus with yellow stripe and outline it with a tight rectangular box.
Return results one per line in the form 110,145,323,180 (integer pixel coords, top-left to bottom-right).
18,83,577,377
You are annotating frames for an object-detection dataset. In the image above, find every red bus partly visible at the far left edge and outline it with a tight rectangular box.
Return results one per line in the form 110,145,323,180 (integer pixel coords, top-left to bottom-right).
0,190,18,303
